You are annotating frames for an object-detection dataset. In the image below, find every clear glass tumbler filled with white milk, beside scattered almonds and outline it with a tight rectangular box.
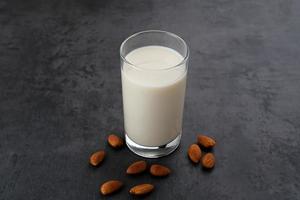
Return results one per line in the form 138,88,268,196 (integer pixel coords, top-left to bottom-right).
120,30,189,158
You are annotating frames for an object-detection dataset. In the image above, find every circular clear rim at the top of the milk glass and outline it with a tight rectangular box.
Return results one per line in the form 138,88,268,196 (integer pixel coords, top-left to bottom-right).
120,30,190,71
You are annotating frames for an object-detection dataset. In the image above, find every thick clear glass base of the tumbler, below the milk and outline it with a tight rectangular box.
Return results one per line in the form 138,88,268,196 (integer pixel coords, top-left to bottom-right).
125,134,181,158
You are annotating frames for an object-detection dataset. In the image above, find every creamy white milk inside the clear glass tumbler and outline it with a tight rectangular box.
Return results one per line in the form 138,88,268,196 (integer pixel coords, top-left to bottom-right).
122,46,186,146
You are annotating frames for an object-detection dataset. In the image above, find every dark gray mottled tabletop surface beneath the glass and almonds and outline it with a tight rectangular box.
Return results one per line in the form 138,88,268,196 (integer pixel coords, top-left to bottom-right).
0,0,300,200
